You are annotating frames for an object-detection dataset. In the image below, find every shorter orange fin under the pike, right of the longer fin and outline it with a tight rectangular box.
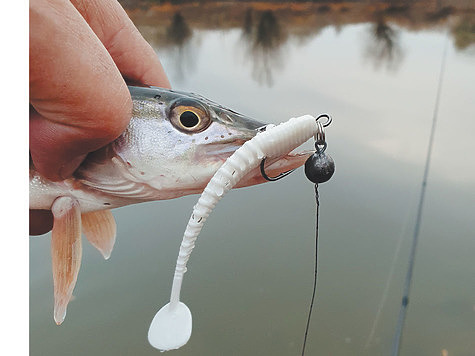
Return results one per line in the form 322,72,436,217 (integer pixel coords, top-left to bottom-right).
81,210,117,260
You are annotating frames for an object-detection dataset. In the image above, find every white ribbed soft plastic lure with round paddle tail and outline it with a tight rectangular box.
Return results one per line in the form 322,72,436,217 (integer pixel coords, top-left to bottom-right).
148,115,322,351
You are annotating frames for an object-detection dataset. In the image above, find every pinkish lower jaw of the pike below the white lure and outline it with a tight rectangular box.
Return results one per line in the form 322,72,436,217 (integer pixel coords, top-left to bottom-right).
235,151,314,188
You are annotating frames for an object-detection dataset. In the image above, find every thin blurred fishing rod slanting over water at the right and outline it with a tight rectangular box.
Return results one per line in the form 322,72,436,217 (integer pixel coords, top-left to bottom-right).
391,35,449,356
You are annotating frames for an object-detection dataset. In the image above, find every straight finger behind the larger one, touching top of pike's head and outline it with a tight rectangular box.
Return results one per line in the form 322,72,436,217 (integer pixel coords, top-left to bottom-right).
71,0,170,88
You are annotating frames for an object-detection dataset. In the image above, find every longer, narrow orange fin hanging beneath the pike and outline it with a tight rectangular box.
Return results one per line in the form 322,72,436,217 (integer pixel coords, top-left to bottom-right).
51,197,82,325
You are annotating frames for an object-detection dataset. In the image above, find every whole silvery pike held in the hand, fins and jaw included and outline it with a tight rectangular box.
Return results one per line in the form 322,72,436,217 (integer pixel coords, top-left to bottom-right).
29,86,311,325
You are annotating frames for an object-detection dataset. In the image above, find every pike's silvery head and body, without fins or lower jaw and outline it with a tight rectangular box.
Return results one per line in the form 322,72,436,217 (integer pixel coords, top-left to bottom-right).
30,87,265,212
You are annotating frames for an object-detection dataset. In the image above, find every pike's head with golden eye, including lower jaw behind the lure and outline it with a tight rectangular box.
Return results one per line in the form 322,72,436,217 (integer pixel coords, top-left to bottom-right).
89,87,308,199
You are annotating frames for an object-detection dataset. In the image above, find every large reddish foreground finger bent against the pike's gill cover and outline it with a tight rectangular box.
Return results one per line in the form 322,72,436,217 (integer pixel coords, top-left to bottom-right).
29,0,132,180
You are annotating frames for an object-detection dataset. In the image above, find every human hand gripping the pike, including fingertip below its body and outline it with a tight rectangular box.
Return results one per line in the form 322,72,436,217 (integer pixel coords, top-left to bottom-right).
29,0,170,235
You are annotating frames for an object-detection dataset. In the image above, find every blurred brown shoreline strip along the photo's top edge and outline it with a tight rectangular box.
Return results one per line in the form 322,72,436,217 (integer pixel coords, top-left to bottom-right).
120,0,475,50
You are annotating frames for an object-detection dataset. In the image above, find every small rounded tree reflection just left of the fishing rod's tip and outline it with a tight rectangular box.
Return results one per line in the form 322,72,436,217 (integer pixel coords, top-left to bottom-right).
365,17,404,70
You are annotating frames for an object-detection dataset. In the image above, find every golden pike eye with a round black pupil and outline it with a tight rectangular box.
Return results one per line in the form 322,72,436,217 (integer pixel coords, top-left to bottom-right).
169,100,211,134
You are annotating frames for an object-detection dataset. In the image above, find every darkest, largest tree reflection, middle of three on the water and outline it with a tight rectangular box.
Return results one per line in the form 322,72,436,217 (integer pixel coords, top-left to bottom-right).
241,9,287,87
